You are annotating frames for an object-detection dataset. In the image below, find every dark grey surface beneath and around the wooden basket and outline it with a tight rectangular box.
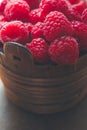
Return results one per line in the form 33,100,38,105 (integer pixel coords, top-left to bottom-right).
0,81,87,130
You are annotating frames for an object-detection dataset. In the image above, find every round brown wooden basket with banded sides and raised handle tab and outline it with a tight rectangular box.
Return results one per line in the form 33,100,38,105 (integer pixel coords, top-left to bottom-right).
0,43,87,113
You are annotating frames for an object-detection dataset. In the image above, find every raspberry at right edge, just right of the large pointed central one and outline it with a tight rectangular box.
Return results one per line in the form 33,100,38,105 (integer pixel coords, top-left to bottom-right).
72,21,87,50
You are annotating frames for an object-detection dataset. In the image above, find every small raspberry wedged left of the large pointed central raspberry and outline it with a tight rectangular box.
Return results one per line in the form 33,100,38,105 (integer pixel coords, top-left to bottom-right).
31,22,43,38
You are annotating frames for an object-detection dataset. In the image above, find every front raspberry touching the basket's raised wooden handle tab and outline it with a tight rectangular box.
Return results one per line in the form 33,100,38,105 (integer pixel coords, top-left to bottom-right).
26,38,48,64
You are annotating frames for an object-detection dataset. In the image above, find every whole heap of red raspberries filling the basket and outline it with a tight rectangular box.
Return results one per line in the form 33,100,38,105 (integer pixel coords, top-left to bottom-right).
0,0,87,64
